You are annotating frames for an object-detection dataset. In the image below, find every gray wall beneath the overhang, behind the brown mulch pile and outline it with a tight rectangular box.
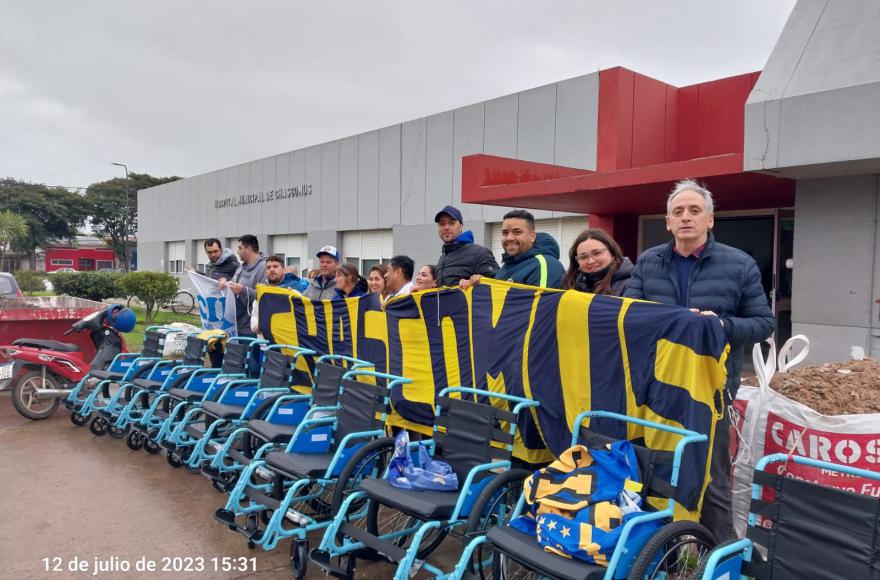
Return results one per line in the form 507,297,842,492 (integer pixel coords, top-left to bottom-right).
792,175,880,362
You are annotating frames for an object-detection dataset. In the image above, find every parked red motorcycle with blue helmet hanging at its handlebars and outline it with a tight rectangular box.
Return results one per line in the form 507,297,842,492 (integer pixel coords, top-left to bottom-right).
0,305,135,421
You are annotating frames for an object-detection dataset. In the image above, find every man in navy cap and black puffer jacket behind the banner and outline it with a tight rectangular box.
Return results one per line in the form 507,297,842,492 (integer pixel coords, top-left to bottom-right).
434,205,498,286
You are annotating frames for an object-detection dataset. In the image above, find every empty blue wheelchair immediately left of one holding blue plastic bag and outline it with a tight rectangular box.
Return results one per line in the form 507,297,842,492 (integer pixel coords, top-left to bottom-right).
214,370,411,577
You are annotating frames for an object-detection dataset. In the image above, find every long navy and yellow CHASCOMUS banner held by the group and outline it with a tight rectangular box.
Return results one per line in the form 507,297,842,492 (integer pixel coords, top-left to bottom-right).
258,279,728,510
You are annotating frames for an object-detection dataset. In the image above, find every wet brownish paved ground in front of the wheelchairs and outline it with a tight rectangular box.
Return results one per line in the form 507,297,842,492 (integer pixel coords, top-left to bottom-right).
0,392,461,580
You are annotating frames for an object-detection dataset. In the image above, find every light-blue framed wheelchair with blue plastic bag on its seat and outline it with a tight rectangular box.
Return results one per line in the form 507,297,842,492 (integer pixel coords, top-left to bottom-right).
310,387,539,580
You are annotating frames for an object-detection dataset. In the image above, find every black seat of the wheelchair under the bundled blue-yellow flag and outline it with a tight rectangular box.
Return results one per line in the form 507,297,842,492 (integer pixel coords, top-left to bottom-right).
486,526,608,580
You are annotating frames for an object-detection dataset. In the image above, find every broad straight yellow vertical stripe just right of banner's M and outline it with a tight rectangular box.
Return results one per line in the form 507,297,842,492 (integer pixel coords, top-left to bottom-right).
556,292,593,426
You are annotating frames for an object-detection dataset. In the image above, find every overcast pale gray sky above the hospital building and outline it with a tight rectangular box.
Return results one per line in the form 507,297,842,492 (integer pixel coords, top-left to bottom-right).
0,0,794,186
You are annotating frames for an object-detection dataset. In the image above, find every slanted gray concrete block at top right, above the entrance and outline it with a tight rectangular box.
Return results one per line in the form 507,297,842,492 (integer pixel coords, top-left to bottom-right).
745,0,880,177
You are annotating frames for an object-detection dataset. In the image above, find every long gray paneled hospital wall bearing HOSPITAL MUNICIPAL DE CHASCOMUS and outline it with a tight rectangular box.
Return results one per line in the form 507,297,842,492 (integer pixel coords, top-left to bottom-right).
138,73,599,269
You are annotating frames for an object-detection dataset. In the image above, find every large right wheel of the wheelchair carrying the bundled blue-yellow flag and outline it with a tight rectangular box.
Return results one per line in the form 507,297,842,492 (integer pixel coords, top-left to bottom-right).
629,521,717,580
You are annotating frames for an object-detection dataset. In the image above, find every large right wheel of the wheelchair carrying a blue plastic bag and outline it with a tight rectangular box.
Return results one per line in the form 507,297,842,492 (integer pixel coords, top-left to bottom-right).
465,469,532,579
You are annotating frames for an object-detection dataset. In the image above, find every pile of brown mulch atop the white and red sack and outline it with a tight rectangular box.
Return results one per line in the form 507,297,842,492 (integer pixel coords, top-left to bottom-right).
742,358,880,415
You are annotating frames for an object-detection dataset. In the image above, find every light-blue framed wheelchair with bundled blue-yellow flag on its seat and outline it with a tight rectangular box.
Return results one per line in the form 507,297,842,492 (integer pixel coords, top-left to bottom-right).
446,411,715,580
